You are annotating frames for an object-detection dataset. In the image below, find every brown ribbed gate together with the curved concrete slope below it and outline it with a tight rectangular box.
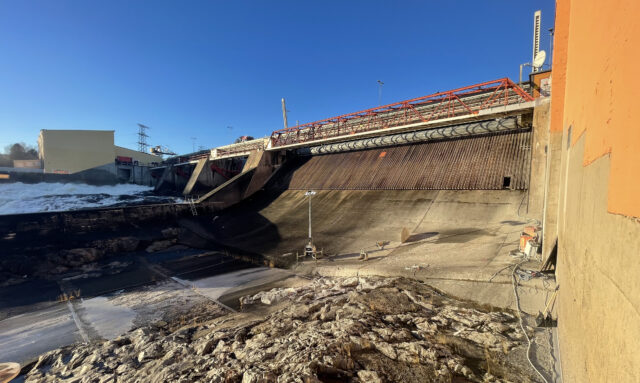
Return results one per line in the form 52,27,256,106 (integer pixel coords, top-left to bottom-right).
202,130,531,264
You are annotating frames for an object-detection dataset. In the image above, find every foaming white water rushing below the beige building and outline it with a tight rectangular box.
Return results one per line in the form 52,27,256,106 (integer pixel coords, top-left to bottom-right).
0,182,180,215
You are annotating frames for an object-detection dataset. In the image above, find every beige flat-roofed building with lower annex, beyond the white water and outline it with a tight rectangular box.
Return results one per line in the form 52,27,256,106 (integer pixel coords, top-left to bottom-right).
38,129,162,185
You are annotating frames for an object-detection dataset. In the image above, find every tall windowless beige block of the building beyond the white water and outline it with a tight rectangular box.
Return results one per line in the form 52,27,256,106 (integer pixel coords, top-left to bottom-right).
38,130,115,174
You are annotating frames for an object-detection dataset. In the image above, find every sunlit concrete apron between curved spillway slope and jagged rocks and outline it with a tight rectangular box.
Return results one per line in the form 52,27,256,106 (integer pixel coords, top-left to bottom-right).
292,224,556,317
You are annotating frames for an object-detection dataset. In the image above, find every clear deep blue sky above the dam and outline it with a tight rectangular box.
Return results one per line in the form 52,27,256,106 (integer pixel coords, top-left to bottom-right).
0,0,555,153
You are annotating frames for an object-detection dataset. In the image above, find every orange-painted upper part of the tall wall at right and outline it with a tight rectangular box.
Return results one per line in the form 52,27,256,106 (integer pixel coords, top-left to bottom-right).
551,0,640,217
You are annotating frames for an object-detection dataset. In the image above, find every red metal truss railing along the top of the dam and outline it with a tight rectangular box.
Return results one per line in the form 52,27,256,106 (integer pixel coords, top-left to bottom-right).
271,78,533,147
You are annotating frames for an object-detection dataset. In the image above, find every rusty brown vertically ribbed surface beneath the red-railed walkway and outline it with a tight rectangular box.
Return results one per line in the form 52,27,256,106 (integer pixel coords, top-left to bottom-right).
284,131,531,190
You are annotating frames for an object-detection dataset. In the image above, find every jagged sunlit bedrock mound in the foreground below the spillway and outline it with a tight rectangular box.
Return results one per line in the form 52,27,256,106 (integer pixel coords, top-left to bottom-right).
25,277,538,383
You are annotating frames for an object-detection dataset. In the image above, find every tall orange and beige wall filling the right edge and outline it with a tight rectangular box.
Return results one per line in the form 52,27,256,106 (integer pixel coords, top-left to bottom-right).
545,0,640,382
